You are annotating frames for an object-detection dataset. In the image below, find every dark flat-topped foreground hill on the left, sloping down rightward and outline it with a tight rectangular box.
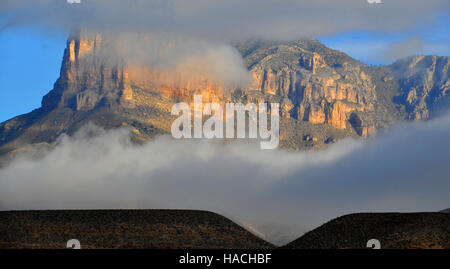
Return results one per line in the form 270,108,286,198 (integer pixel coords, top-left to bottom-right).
0,210,274,249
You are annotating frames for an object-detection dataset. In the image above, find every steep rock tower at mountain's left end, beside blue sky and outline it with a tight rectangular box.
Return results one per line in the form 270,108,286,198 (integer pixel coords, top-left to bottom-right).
42,32,123,111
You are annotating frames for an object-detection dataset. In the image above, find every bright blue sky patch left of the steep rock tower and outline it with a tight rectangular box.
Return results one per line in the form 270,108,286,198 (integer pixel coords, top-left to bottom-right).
0,28,66,122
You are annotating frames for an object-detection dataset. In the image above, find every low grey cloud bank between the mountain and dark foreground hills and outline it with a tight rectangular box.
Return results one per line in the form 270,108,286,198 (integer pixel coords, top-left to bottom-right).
0,115,450,244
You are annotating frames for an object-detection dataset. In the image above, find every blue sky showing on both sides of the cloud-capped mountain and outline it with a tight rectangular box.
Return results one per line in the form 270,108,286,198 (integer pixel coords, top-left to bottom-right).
0,18,450,122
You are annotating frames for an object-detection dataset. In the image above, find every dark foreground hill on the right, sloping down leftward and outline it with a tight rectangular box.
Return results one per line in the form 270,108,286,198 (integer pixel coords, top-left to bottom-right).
283,213,450,249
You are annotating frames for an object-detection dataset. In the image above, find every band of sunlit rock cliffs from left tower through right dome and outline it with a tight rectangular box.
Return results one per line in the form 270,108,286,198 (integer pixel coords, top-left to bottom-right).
42,30,377,136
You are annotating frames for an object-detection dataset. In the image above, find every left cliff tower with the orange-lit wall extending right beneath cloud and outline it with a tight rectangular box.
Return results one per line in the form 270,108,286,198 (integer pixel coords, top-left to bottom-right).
42,31,229,111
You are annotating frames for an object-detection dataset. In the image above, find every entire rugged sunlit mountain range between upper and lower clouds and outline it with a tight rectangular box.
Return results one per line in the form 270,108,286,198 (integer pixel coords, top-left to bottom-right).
0,31,450,154
